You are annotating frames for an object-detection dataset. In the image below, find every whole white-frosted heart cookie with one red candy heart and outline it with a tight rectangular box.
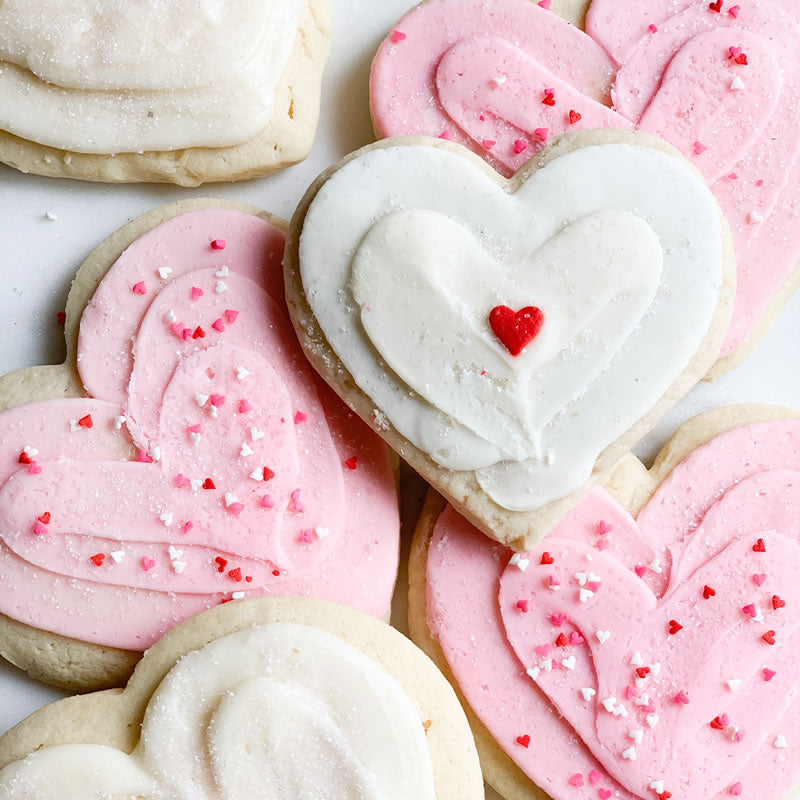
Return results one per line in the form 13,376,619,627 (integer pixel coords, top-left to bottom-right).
285,131,734,547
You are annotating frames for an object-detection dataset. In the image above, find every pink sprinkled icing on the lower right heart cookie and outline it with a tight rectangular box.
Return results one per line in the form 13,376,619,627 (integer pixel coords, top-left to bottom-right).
427,420,800,800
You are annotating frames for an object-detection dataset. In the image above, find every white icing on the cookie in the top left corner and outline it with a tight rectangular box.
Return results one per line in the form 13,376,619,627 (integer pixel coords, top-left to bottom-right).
0,0,305,154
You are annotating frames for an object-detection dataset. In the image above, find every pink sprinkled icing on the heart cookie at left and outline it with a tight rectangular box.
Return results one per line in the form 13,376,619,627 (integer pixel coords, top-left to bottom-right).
0,209,399,650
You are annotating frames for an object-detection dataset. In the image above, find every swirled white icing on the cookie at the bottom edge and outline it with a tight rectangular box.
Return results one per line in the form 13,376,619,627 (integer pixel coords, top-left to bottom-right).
0,623,435,800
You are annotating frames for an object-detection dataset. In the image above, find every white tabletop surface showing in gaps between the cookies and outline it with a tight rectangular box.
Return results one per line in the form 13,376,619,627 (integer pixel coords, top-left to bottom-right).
0,0,800,792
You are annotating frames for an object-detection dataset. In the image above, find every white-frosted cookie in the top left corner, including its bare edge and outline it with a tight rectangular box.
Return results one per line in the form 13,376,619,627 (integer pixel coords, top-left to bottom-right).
0,0,330,186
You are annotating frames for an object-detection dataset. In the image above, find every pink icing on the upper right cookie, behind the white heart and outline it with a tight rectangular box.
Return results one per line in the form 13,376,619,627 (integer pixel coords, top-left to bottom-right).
370,0,800,356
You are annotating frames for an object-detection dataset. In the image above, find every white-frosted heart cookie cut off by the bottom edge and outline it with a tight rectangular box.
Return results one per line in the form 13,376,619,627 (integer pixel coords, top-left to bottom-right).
0,598,483,800
